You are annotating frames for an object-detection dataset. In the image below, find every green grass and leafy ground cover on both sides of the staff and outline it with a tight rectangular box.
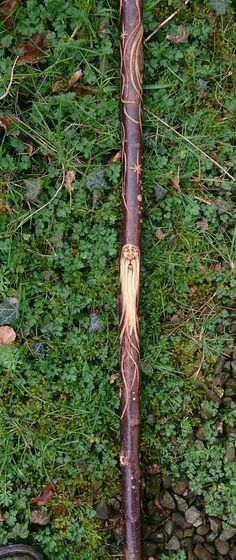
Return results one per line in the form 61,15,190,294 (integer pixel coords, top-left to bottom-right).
0,0,236,560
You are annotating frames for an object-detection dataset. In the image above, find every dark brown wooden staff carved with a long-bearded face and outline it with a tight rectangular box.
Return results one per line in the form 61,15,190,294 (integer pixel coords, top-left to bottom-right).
120,0,143,560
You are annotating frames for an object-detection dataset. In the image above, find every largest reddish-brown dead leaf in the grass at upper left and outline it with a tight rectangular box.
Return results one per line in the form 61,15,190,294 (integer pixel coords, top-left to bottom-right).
17,31,50,66
